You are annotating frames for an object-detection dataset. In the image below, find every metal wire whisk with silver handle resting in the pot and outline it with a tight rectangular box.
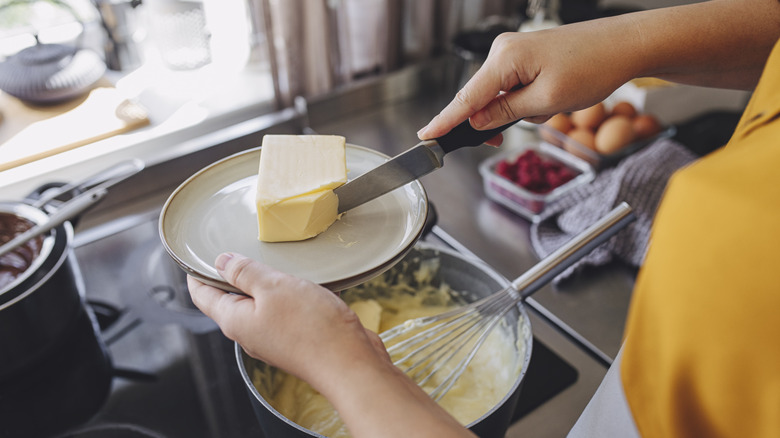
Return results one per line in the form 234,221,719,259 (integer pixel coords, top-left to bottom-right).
380,202,634,400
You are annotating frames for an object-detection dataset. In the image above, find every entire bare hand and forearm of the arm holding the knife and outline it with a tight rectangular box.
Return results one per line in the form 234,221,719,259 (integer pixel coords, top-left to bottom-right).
424,0,780,145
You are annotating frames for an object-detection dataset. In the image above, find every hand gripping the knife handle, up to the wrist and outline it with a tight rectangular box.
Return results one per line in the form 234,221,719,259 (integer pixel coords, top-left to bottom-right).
418,23,634,145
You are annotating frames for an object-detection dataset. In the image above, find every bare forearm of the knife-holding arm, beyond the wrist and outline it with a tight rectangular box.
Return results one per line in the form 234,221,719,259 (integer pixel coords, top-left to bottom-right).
616,0,780,90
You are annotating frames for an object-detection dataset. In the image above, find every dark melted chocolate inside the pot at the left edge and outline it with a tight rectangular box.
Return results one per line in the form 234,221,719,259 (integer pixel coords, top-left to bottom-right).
0,213,43,289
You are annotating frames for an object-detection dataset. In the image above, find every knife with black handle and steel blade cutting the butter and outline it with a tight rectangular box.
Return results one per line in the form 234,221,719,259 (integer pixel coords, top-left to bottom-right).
333,120,517,213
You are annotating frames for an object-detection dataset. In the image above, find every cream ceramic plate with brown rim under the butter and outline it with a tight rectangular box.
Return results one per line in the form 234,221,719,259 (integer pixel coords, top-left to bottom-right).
159,144,428,292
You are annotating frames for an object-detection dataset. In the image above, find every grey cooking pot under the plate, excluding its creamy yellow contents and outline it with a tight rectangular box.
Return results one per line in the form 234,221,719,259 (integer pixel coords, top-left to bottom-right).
235,241,533,438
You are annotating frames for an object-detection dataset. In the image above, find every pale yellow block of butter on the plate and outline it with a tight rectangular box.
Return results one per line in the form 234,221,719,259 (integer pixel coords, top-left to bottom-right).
256,135,347,242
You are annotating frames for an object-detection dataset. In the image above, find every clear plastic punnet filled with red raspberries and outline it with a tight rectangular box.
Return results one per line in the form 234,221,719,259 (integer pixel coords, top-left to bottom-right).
479,142,595,221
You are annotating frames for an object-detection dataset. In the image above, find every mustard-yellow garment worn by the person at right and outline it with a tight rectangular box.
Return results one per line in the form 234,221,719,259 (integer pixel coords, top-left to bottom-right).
620,39,780,437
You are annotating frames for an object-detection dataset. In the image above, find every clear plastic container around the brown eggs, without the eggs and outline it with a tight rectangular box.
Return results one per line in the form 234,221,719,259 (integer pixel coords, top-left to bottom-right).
538,125,677,170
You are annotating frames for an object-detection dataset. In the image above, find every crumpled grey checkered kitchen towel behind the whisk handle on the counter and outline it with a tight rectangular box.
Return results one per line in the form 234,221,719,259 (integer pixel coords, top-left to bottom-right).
531,139,696,284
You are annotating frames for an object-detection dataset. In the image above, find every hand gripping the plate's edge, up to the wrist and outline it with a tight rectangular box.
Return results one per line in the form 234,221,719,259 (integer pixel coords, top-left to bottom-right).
187,254,389,387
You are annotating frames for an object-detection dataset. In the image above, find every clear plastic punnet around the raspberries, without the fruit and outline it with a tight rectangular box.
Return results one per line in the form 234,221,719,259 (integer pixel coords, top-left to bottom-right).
479,142,595,222
